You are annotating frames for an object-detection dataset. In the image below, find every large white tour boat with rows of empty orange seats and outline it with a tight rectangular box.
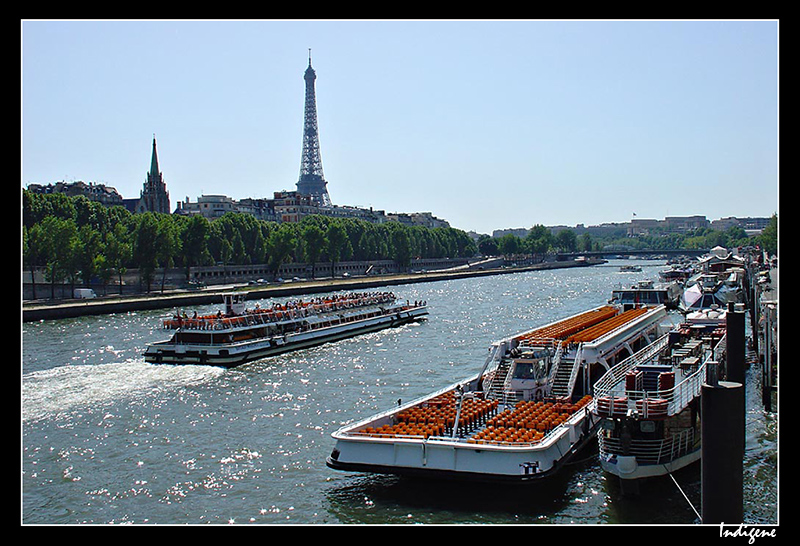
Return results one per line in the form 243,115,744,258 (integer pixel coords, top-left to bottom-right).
326,305,666,482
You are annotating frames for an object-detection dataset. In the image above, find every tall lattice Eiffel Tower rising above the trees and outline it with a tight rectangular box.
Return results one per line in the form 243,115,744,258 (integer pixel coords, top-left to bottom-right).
297,49,331,207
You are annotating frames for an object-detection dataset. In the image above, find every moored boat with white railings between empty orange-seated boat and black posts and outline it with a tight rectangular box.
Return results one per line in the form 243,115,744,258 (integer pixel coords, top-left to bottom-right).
592,323,725,487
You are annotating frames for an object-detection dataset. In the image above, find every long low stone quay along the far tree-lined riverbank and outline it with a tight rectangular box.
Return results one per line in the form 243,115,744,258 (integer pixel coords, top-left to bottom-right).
22,258,606,322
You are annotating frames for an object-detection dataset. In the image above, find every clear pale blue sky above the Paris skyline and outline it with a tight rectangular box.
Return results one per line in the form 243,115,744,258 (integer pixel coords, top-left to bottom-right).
21,20,779,234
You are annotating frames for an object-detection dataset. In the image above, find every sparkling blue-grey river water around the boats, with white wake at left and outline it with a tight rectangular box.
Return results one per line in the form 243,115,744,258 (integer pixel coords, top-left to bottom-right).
21,260,778,525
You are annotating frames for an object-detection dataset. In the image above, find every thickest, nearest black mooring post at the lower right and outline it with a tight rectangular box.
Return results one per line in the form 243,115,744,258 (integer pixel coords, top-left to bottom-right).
700,363,745,524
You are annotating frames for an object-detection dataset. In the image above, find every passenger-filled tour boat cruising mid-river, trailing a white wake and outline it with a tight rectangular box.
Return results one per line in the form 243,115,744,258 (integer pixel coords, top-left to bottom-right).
144,292,428,368
